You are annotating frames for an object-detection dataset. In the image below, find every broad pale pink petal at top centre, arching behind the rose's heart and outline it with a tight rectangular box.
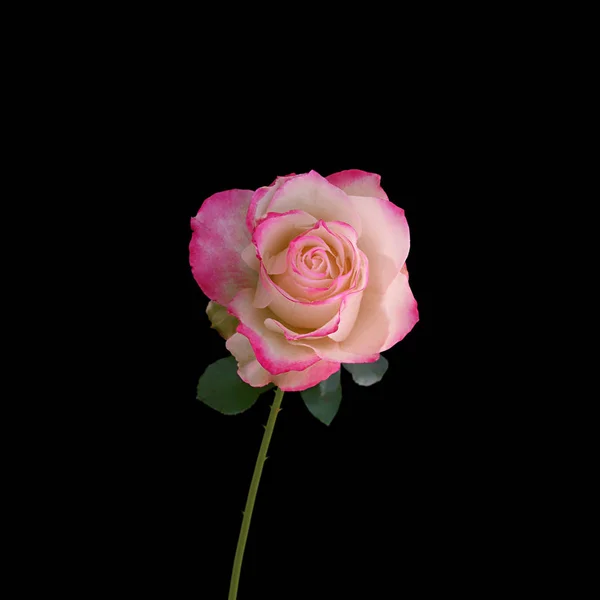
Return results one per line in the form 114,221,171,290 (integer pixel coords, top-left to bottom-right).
267,171,361,236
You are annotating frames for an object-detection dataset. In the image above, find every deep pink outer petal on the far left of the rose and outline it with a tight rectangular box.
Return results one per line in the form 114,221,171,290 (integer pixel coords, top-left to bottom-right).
190,190,257,304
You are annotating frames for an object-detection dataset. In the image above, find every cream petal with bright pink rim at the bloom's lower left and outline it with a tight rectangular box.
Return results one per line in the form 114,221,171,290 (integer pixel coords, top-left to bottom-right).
228,289,319,375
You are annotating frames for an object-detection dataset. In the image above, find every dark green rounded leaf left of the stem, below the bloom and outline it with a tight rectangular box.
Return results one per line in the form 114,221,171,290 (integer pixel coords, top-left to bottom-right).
198,356,273,415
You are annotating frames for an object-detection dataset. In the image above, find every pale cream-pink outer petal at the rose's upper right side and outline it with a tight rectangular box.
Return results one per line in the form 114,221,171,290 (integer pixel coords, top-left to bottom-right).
348,196,410,293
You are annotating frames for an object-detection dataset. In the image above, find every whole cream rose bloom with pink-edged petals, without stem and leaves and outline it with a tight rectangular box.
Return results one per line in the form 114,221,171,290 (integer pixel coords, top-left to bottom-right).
190,170,419,391
